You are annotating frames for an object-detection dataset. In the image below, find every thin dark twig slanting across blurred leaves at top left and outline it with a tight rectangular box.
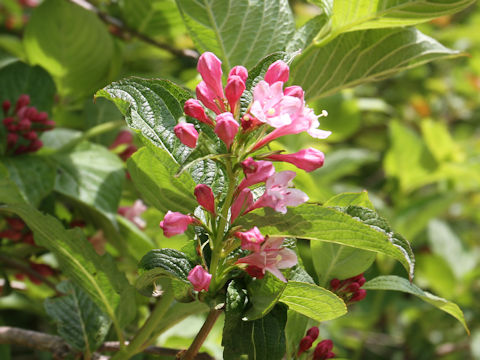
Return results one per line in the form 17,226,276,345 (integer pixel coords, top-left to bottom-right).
67,0,198,60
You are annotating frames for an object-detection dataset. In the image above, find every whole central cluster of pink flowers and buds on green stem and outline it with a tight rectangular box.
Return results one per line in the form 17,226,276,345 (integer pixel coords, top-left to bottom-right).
160,52,330,291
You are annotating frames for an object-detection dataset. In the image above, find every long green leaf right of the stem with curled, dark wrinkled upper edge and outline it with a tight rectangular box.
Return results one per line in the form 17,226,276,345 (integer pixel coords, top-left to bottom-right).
243,204,414,277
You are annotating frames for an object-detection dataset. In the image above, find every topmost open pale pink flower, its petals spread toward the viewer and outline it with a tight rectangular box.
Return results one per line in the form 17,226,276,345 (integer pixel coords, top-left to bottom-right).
250,81,303,128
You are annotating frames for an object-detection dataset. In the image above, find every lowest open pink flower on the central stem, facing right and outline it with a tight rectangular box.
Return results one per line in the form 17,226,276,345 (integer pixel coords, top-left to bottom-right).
236,237,298,282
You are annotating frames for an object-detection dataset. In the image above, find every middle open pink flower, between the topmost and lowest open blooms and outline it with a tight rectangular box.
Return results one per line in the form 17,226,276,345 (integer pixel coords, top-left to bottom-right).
248,171,308,214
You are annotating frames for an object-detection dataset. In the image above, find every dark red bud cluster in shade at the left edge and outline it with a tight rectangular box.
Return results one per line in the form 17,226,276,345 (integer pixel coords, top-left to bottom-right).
2,94,55,155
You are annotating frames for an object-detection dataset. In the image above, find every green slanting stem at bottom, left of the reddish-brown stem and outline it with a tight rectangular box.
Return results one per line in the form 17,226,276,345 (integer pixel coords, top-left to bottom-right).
111,291,173,360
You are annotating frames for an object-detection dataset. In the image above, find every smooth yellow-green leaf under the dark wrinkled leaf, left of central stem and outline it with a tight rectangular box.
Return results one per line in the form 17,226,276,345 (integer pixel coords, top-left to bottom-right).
127,147,198,214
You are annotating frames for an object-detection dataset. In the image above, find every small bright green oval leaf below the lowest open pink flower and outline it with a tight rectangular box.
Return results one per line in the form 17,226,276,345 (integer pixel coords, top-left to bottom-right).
280,281,347,322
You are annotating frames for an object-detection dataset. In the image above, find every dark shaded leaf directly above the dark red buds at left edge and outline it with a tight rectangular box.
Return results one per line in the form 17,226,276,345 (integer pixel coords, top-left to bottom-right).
0,61,55,112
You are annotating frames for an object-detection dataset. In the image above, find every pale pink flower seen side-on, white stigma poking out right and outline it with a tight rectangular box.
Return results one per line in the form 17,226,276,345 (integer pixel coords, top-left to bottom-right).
253,107,331,150
